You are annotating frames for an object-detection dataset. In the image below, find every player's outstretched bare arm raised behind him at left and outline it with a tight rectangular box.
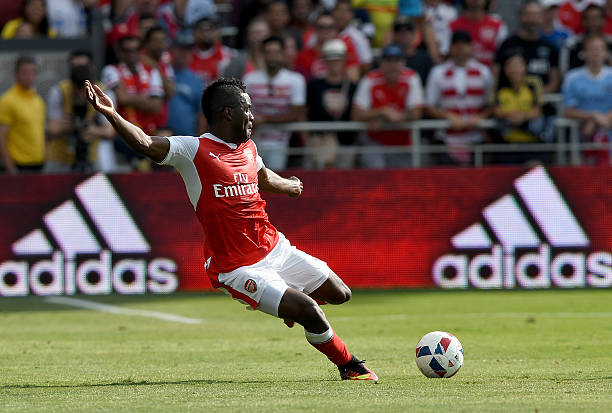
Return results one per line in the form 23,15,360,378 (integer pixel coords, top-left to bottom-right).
85,81,170,162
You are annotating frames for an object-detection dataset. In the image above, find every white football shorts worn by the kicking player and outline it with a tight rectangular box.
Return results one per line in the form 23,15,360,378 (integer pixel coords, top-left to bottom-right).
218,232,331,317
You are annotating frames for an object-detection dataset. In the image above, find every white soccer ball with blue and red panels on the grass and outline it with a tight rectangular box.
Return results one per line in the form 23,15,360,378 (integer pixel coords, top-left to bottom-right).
416,331,463,378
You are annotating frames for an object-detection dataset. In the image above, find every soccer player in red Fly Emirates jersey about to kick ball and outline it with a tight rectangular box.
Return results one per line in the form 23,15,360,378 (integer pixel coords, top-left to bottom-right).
87,79,378,381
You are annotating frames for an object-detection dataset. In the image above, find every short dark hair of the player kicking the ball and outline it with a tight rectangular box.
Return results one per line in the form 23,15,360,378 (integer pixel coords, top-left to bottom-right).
202,77,246,125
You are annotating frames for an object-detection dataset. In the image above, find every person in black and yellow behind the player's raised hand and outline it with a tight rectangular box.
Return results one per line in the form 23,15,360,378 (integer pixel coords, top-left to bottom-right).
45,51,116,173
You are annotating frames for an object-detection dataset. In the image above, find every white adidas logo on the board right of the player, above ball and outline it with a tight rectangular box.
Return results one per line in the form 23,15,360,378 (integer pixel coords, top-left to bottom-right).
433,166,612,288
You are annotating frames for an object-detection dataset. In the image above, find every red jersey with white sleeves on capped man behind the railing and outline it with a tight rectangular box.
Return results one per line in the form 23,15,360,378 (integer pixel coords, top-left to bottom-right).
353,68,423,145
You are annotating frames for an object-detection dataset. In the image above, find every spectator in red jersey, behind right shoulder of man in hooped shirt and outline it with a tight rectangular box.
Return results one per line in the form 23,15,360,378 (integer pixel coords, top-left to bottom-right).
450,0,508,67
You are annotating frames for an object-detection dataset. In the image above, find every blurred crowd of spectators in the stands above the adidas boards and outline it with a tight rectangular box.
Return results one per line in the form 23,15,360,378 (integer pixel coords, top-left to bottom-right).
0,0,612,174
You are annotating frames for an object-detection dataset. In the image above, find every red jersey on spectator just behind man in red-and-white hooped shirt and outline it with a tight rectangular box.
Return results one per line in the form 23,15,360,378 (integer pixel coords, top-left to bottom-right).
450,15,508,67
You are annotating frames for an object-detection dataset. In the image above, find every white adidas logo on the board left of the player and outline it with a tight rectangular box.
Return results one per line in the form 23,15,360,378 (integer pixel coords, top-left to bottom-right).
0,174,178,296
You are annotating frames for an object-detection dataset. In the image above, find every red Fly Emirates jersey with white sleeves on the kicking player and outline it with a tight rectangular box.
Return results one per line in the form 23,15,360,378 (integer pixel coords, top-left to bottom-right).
161,133,279,287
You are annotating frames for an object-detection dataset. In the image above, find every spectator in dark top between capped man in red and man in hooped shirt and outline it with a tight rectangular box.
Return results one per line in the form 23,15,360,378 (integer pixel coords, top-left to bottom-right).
392,16,434,84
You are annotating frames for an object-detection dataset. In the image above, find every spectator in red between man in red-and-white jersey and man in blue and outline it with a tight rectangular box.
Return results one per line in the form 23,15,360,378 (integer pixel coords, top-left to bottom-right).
141,26,175,128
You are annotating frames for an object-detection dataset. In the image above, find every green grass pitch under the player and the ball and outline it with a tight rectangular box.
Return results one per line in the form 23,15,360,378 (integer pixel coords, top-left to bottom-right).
0,290,612,413
